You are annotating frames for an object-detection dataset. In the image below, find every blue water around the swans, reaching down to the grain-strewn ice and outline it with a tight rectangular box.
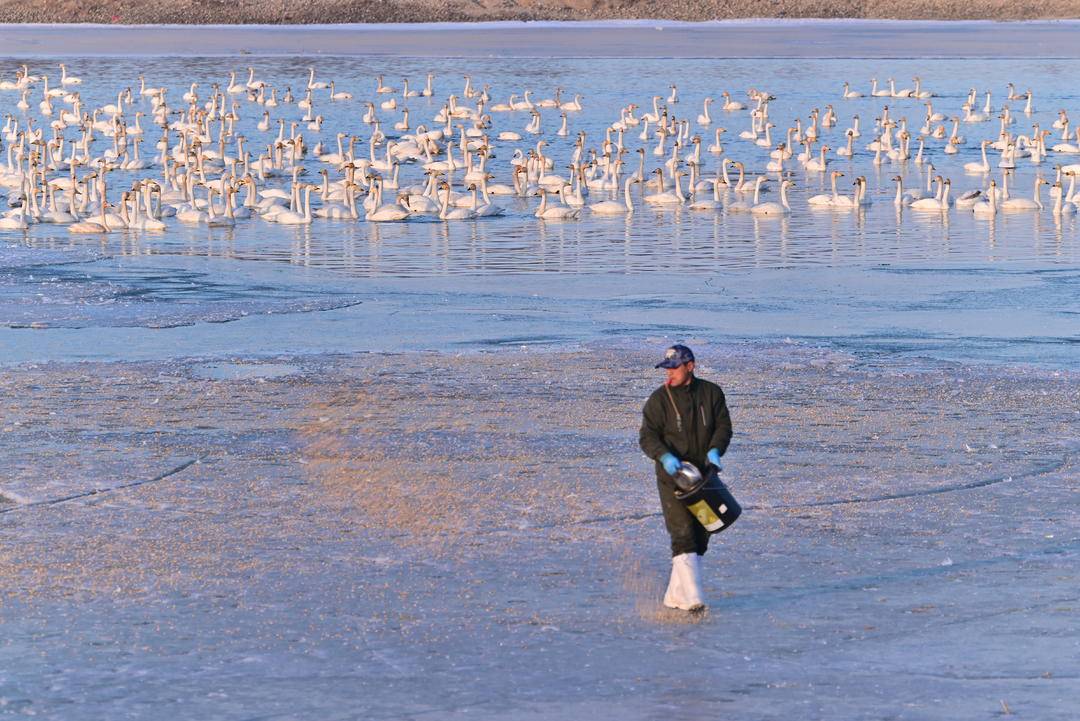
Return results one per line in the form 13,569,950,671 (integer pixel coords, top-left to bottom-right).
0,42,1080,369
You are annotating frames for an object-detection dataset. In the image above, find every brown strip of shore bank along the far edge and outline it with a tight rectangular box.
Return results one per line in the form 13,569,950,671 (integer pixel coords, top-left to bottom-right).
0,0,1080,25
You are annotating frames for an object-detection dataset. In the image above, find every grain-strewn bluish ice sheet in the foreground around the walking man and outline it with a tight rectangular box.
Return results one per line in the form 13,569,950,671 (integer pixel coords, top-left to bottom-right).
0,344,1080,721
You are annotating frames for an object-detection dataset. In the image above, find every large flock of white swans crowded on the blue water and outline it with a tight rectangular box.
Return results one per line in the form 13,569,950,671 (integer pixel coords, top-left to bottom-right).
0,64,1080,233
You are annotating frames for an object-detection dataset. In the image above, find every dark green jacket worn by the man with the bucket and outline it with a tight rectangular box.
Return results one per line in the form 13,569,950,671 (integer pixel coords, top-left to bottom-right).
638,378,731,479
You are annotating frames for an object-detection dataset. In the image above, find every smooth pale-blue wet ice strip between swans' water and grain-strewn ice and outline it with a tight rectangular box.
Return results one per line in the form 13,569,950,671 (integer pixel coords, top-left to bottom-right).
6,259,1080,368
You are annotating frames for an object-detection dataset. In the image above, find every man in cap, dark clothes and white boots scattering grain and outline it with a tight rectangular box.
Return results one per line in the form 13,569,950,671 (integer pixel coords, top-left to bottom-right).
638,345,731,611
